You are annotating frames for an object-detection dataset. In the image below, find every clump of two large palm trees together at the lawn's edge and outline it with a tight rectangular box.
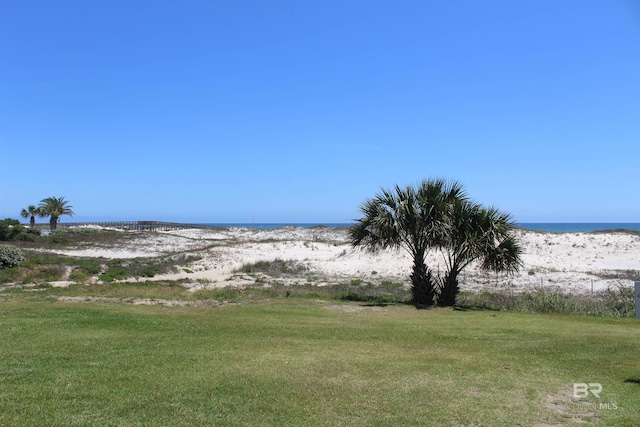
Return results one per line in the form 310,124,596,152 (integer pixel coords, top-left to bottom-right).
349,179,522,307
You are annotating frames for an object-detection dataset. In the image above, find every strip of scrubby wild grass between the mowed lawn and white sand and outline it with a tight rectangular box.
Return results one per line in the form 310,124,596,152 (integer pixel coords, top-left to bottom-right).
0,270,635,317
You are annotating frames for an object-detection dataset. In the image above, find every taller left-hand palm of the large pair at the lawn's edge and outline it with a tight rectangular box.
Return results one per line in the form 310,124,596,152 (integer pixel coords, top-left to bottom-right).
349,179,467,306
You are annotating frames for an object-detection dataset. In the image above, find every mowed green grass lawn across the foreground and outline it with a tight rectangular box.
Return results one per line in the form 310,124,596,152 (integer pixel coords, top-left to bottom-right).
0,297,640,426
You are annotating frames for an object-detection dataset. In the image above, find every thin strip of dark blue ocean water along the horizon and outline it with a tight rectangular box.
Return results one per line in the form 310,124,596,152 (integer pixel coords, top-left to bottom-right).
205,222,640,233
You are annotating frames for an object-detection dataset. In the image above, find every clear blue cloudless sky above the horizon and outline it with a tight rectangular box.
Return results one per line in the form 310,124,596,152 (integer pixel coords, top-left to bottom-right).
0,0,640,223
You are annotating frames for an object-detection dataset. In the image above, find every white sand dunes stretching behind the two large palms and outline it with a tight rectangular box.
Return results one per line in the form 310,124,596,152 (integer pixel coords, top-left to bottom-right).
41,227,640,293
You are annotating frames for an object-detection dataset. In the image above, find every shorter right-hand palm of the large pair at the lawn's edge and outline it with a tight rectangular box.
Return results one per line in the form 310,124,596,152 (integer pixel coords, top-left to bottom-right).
438,201,522,306
